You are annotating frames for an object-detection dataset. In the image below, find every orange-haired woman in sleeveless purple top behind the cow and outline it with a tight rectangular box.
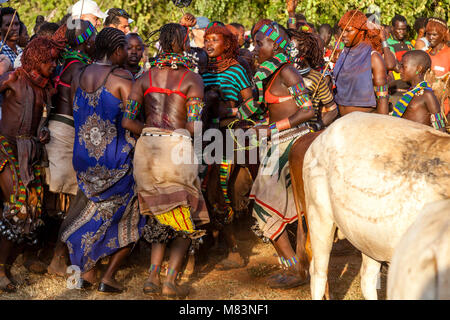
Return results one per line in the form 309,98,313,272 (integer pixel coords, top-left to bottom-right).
333,10,389,115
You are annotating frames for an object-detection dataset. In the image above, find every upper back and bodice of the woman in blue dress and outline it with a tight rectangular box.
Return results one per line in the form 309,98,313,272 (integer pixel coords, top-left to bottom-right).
73,65,134,189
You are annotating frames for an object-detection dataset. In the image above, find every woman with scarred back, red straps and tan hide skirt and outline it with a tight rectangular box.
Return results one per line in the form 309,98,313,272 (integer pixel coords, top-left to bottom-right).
122,23,209,298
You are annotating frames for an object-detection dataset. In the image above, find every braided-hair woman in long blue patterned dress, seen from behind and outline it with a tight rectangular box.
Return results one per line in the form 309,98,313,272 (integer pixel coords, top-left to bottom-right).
61,28,145,293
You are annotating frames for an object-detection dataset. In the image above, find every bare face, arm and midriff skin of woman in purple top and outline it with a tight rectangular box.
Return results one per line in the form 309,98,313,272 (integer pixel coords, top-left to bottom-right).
339,26,389,115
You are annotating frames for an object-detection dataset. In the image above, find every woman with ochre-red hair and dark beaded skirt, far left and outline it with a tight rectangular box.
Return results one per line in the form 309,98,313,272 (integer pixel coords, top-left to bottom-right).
0,37,60,292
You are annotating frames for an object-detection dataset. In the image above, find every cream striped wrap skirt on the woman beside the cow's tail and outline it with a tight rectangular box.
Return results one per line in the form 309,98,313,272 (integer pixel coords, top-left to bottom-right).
250,124,311,240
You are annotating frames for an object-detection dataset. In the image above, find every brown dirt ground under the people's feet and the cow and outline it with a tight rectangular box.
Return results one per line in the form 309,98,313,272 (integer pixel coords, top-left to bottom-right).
0,218,387,300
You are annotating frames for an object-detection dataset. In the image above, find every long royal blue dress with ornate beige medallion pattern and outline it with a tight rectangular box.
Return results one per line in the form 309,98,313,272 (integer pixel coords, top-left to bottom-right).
62,68,145,272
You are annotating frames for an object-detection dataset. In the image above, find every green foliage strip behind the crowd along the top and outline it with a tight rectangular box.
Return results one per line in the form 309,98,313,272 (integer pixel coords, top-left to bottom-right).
9,0,450,43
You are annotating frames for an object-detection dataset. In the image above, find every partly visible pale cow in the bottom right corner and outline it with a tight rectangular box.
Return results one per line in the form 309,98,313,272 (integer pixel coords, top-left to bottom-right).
387,199,450,300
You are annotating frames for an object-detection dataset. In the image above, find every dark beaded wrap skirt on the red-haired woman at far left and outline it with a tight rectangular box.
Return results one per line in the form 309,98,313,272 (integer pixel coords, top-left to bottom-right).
0,135,43,244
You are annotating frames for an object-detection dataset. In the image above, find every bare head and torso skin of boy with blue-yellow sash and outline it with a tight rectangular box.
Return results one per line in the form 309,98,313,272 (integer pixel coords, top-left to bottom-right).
400,56,445,132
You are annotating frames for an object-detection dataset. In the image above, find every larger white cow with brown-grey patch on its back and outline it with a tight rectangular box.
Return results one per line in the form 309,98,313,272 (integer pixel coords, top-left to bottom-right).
303,112,450,299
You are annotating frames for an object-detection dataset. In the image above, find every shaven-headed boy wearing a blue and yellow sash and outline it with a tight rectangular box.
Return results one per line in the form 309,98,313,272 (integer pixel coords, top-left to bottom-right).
392,50,446,132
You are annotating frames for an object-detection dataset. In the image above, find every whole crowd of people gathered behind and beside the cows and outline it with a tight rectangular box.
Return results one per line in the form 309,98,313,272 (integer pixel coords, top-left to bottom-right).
0,0,450,298
